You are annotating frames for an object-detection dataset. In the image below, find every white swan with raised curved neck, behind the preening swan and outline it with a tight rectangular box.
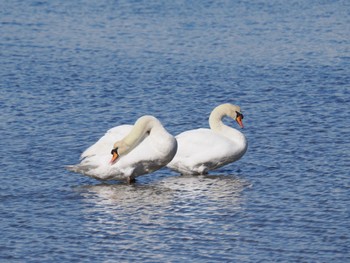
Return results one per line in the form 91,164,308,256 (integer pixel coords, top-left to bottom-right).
167,103,248,174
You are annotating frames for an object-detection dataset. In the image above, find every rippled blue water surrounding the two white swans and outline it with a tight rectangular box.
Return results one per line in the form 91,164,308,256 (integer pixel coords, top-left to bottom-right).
0,0,350,263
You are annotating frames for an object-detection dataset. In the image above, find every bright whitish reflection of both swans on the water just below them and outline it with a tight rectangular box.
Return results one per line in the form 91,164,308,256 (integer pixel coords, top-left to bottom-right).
79,175,250,216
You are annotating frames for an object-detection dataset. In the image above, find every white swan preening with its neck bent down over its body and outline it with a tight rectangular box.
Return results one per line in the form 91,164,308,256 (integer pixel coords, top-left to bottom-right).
67,115,177,183
